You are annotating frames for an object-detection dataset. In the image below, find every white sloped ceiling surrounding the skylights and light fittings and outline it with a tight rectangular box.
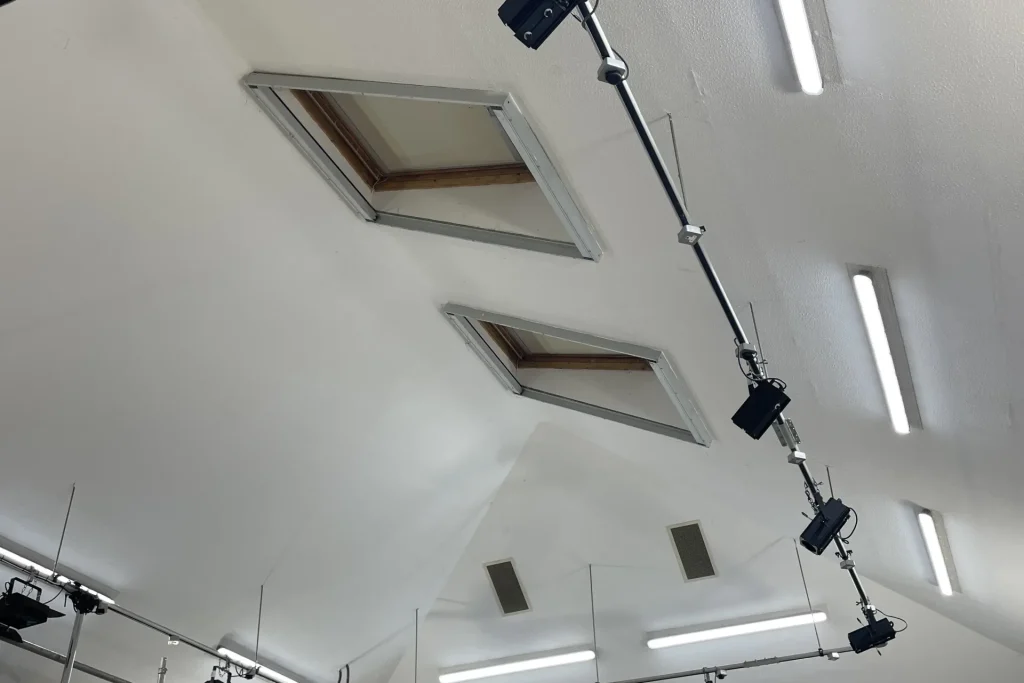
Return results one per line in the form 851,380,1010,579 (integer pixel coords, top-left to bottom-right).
0,0,1024,683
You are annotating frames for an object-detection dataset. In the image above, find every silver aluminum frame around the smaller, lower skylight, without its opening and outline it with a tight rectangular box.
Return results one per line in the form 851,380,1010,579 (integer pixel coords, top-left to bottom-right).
441,303,712,447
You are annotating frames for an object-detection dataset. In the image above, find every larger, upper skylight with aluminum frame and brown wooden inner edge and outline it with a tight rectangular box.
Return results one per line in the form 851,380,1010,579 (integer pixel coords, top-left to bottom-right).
244,73,601,261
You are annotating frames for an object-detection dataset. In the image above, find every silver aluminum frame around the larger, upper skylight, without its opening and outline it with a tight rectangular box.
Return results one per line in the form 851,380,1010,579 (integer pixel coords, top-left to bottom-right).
242,72,602,261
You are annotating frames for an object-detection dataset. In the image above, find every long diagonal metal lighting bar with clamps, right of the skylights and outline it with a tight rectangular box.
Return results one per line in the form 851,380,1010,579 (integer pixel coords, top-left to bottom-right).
579,0,877,623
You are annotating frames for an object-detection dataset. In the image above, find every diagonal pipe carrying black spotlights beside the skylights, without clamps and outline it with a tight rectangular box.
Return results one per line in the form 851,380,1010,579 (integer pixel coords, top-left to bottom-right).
578,0,874,618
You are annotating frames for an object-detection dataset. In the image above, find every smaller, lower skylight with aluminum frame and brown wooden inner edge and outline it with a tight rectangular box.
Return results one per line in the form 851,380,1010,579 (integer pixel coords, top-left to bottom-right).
441,304,711,446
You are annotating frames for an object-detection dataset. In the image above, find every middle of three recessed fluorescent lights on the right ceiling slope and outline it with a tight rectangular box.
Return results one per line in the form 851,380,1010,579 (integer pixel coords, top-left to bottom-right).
851,266,922,434
